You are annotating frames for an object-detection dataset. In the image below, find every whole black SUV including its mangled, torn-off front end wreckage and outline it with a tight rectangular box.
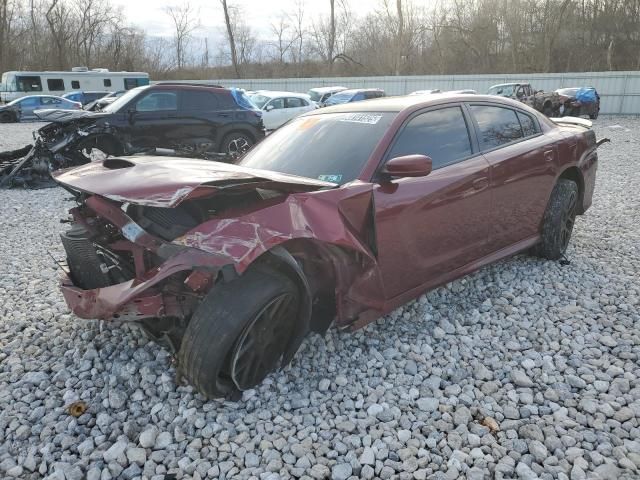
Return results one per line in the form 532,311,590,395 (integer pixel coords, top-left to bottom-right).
0,83,265,188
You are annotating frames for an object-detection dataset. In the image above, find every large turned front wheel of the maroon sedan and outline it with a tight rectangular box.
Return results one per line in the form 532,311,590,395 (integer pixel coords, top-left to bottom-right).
178,268,301,398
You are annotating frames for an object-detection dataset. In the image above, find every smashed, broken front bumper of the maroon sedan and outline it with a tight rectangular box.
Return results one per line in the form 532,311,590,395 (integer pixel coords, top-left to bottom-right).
60,196,235,321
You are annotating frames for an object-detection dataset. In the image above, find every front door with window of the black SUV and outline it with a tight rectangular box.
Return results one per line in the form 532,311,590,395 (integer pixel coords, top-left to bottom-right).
126,89,180,148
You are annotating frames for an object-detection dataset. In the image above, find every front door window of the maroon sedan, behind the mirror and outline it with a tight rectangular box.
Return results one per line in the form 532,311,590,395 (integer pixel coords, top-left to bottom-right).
388,107,472,169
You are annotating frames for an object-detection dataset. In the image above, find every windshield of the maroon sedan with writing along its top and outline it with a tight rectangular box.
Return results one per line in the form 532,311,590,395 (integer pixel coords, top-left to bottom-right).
239,112,397,185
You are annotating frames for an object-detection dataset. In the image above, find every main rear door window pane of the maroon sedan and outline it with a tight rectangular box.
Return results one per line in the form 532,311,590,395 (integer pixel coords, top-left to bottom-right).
471,105,522,150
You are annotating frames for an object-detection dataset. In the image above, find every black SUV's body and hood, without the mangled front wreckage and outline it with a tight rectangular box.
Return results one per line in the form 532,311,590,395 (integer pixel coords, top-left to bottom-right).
37,83,265,155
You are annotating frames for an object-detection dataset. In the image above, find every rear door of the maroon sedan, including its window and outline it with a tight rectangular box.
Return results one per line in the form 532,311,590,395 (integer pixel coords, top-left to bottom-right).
469,103,557,251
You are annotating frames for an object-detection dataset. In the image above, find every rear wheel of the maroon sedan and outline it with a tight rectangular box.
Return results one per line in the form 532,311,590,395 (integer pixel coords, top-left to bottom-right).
533,178,578,260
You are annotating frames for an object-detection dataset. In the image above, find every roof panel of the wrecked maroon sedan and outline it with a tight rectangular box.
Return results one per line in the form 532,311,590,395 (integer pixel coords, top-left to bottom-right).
311,92,523,115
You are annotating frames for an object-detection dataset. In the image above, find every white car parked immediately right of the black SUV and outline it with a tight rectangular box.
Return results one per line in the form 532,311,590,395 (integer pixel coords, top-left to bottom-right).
249,90,318,130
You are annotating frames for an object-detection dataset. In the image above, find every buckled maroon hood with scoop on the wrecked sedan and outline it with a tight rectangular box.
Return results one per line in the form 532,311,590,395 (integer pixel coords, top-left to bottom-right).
53,156,337,208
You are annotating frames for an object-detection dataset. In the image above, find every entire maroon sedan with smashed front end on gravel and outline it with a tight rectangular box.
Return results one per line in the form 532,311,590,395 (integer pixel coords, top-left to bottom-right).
55,95,600,397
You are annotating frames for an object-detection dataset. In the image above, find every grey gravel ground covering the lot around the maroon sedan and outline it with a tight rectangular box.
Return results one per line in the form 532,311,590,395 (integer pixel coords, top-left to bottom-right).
0,118,640,480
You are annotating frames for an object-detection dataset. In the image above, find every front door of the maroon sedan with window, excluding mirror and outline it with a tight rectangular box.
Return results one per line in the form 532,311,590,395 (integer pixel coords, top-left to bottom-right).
374,104,491,299
